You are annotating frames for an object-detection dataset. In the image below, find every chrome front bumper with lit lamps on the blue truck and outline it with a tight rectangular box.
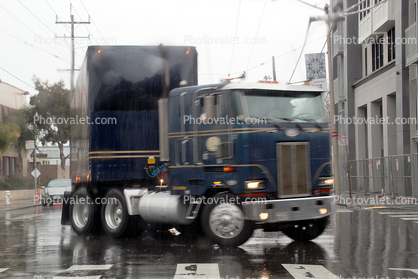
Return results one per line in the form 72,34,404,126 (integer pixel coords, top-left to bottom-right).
242,196,335,223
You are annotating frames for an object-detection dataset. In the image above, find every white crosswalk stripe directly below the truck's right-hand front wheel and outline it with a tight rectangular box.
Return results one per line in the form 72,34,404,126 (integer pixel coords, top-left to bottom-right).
282,264,337,279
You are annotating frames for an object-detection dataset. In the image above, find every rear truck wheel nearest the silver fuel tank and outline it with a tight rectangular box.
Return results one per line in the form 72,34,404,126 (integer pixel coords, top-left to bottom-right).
101,189,143,238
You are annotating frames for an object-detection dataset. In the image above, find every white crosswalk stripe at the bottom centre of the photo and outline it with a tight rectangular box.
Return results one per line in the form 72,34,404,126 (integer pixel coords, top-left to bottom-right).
174,263,221,279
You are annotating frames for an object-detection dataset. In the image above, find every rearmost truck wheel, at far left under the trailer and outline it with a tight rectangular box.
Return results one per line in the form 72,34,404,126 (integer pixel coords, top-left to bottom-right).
70,188,101,235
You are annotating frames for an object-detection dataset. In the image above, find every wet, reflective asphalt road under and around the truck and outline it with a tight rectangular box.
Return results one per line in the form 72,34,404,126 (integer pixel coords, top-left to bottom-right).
0,207,418,279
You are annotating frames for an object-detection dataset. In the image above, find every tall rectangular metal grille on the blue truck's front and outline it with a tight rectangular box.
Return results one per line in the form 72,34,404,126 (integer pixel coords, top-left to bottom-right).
276,142,311,198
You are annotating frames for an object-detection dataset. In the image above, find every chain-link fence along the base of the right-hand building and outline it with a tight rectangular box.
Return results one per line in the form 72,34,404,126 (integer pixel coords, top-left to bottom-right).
340,154,418,197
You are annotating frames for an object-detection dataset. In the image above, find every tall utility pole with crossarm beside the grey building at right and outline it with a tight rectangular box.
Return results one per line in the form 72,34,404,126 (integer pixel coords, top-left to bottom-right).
309,4,345,196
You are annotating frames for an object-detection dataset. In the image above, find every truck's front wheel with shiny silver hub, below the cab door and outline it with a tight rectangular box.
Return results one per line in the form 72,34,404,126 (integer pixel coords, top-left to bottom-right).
201,193,254,246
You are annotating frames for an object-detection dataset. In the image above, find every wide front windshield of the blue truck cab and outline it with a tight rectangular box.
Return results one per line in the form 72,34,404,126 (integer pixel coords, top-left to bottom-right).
235,90,327,123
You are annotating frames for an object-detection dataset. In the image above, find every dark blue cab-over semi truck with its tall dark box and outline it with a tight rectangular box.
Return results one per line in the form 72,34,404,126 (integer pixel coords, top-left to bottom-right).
62,46,334,246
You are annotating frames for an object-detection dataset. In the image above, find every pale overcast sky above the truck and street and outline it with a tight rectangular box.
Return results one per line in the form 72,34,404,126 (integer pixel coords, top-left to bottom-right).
0,0,329,95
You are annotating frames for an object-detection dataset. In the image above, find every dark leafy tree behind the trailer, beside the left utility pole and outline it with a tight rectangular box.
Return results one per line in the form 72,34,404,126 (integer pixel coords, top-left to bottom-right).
29,78,70,173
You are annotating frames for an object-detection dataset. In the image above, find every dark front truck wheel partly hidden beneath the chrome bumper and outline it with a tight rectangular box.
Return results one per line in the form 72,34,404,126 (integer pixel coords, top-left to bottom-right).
283,216,329,241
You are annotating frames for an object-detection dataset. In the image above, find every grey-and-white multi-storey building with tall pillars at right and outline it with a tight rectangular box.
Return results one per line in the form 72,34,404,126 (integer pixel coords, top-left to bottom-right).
331,0,418,196
